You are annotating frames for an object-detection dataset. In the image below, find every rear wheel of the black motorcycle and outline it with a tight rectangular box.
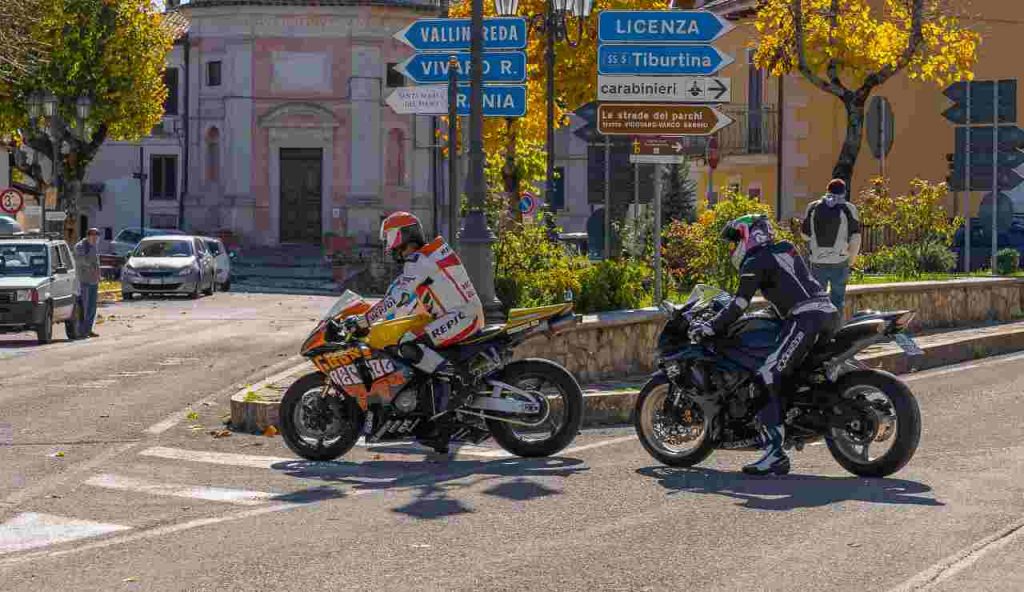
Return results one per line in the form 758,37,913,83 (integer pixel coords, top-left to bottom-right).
825,371,921,477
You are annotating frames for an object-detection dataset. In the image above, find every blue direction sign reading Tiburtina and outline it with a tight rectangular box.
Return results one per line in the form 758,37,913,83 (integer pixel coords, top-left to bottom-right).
597,45,732,76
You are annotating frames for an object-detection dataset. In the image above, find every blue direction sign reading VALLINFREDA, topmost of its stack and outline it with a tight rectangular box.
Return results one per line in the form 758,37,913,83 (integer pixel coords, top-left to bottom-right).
394,16,526,51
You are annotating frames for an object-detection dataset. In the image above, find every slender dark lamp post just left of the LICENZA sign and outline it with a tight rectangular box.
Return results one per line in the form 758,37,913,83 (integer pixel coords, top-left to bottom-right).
495,0,594,220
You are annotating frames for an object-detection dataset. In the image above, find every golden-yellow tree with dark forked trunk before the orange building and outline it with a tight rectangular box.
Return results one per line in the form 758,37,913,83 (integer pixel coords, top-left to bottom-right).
755,0,980,182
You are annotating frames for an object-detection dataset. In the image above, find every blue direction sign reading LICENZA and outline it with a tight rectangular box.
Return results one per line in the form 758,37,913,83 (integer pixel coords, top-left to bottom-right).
597,10,733,43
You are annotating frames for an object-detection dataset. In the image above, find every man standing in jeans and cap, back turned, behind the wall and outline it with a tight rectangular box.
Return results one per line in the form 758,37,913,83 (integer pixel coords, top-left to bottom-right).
801,179,860,313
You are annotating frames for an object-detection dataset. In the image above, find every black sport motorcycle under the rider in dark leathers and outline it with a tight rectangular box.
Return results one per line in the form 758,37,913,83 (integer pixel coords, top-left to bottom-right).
634,286,922,477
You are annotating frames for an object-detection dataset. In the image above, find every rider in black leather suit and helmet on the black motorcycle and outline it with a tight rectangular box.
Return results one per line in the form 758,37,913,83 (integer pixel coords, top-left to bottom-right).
690,215,840,475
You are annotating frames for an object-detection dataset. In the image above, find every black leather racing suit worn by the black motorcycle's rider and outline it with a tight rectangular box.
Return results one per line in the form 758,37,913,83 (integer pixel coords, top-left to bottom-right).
712,241,840,427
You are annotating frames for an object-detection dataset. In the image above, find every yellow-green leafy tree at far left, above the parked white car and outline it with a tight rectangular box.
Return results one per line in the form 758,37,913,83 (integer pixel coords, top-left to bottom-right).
0,0,175,224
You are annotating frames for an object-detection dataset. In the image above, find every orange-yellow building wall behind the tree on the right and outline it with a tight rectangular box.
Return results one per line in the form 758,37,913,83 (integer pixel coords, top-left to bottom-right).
693,0,1024,217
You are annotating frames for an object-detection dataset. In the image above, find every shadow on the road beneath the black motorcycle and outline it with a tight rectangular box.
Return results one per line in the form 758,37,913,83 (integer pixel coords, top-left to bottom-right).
637,466,945,511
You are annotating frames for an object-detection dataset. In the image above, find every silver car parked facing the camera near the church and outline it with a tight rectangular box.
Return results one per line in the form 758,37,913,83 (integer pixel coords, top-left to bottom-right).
121,235,217,300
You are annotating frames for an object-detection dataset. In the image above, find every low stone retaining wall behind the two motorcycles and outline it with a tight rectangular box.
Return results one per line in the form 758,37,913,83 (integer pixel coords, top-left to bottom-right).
516,278,1024,382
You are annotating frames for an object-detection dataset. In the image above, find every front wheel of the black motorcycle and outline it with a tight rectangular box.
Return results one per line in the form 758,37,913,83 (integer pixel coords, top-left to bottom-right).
633,377,715,467
